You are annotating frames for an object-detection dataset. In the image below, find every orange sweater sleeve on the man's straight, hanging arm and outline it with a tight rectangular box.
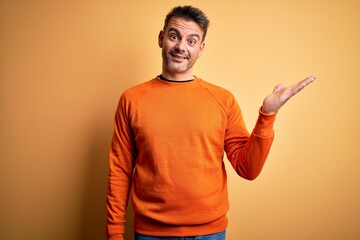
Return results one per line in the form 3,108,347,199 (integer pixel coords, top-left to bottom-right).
107,95,136,240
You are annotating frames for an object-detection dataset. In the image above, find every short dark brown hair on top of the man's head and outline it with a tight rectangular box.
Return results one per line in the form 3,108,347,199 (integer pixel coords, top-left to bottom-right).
164,6,210,41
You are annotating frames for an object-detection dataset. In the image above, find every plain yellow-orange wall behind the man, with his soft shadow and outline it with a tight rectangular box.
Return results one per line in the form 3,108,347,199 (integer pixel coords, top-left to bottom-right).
0,0,360,240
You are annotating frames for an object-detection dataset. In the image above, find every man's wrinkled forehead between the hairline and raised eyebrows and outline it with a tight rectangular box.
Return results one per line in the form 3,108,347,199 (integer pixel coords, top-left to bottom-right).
165,17,203,37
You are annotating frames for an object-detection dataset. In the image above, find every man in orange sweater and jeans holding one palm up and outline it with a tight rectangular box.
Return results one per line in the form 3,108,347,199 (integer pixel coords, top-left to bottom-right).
107,6,315,240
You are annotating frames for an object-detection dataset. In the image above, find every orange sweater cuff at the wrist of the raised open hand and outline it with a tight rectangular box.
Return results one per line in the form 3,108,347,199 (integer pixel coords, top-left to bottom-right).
253,108,276,138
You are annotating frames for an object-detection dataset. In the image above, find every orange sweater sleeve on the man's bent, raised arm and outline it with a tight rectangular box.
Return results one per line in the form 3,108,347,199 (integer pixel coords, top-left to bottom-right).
224,95,276,180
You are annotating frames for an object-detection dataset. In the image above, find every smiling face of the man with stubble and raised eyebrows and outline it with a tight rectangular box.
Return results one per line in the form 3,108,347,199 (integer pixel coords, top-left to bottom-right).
159,17,205,73
